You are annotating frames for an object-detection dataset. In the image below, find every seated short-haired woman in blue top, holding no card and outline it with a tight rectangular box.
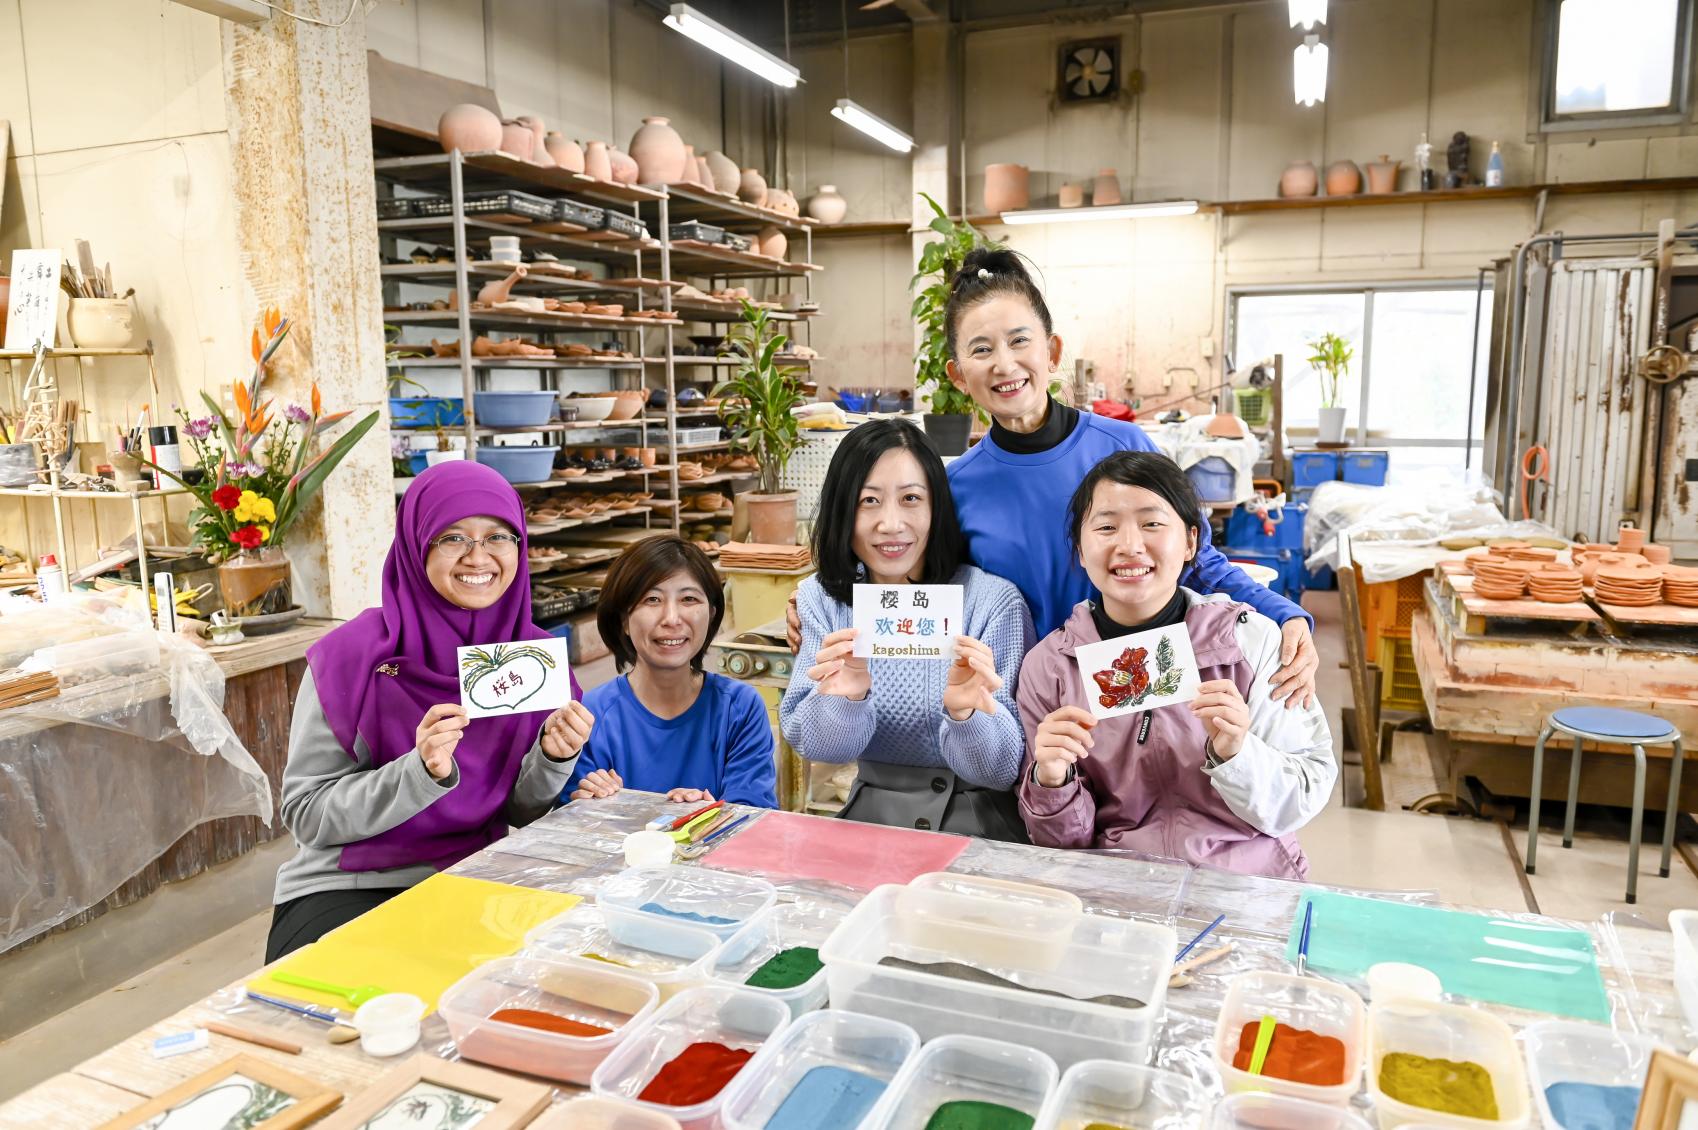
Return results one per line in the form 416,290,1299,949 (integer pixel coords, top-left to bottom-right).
560,535,778,809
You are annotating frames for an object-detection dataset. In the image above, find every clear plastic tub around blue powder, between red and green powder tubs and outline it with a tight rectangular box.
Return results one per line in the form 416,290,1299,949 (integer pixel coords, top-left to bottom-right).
720,1008,920,1130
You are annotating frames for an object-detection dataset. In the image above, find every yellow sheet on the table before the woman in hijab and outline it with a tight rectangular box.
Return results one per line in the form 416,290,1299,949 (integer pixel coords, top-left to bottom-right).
248,875,581,1011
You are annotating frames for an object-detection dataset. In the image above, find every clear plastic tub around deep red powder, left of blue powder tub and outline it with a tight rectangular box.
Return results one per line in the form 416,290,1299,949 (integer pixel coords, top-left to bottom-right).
589,986,790,1130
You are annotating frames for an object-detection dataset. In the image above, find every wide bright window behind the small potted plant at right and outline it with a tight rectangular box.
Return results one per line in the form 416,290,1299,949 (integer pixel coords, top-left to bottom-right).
1228,282,1493,481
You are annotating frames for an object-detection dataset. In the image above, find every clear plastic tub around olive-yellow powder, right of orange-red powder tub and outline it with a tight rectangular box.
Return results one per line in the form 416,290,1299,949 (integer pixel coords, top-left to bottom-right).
1367,999,1532,1130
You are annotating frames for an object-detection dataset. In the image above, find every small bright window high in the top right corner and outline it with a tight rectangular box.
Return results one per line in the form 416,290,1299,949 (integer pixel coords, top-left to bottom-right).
1545,0,1693,129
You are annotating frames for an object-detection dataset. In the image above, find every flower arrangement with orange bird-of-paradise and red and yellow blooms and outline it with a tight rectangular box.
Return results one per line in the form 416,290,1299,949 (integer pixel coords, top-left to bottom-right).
149,306,377,562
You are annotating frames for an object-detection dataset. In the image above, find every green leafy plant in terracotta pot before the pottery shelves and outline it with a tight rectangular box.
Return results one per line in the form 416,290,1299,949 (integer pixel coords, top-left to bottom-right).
713,299,803,545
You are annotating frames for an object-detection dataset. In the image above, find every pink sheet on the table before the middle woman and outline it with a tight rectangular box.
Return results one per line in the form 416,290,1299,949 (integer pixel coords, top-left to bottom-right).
701,812,968,890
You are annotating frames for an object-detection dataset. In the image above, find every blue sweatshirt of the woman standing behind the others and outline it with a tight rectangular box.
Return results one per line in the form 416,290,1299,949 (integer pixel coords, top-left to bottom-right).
949,413,1314,639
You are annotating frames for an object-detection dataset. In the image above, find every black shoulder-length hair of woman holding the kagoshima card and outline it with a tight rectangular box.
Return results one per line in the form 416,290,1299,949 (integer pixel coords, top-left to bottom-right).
813,420,966,605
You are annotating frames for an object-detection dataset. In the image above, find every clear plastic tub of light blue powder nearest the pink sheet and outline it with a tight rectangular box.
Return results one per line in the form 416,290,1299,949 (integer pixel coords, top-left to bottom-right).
596,867,778,950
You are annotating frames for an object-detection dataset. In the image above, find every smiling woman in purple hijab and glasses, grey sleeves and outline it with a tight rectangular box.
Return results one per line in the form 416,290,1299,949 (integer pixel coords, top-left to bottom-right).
265,462,594,962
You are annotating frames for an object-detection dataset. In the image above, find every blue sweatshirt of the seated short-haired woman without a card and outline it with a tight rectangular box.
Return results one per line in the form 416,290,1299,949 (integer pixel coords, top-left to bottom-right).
560,675,778,809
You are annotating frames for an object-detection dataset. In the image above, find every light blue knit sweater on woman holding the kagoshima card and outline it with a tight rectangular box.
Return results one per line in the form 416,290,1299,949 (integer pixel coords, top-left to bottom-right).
778,566,1036,788
